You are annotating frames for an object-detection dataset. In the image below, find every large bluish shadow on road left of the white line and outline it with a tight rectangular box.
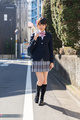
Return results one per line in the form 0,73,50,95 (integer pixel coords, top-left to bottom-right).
0,64,27,98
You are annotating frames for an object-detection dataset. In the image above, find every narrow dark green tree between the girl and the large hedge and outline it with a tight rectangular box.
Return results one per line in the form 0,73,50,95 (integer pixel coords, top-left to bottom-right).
42,0,62,49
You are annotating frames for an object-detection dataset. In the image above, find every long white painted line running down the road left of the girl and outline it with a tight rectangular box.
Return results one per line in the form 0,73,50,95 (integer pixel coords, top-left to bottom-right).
23,65,34,120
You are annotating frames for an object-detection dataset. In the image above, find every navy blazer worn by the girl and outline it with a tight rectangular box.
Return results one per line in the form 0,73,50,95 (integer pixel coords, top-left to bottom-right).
29,32,54,63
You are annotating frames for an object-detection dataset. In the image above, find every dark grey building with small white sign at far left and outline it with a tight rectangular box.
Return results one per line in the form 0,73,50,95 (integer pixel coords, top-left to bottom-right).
0,5,16,55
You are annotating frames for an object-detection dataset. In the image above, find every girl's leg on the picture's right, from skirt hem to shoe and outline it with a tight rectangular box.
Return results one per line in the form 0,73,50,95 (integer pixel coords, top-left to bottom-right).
39,71,48,105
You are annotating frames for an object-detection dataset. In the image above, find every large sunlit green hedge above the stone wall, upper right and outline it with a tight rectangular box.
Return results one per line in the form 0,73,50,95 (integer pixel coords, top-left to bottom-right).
51,0,80,47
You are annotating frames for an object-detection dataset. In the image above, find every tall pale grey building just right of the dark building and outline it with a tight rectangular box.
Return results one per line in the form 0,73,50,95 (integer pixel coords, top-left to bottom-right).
16,0,28,43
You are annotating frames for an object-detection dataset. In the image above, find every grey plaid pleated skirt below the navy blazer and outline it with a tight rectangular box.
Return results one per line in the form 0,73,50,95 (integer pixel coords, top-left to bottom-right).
32,59,50,72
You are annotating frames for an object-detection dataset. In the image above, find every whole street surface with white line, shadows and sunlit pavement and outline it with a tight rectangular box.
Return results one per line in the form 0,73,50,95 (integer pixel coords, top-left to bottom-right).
0,59,80,120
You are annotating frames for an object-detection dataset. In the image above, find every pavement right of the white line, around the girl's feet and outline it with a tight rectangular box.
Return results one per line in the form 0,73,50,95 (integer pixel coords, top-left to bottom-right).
32,70,80,120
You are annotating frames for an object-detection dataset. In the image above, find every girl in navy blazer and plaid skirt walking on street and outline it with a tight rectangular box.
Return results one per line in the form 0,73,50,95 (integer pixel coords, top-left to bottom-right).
29,17,54,105
